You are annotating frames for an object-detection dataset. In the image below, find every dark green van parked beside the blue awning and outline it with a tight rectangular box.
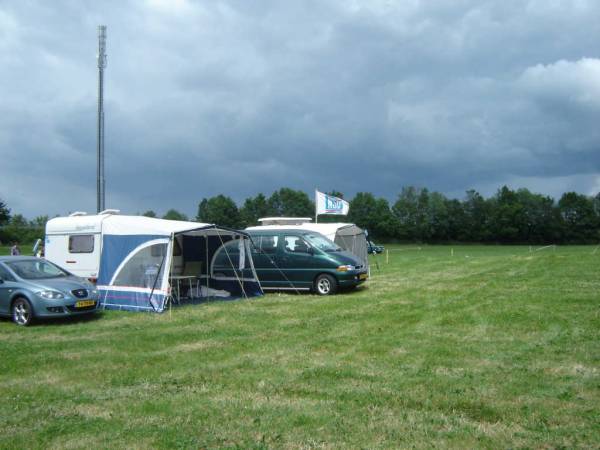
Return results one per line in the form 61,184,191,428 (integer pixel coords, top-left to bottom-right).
243,227,369,295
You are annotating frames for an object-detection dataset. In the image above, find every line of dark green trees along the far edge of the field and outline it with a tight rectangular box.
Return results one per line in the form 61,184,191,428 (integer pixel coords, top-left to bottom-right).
0,186,600,244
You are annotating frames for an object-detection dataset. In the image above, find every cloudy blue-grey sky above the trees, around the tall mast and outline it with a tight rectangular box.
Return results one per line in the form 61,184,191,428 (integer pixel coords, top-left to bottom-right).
0,0,600,218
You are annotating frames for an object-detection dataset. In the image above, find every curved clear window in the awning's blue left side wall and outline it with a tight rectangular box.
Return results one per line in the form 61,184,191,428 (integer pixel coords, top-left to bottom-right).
113,244,167,288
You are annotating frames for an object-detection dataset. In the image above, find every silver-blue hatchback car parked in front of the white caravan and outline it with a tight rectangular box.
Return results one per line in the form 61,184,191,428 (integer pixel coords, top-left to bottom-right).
0,256,99,326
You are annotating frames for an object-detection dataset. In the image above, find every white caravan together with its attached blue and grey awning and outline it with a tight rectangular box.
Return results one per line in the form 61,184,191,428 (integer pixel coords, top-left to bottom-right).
45,210,262,312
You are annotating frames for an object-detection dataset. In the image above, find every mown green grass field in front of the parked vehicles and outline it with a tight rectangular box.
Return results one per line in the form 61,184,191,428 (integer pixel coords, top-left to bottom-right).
0,246,600,448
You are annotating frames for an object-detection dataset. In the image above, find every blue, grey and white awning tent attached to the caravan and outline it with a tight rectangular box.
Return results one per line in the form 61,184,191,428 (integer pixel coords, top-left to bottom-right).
97,215,262,312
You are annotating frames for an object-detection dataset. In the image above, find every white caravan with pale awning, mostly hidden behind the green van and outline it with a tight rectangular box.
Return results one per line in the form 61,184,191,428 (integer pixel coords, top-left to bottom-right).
246,217,369,267
